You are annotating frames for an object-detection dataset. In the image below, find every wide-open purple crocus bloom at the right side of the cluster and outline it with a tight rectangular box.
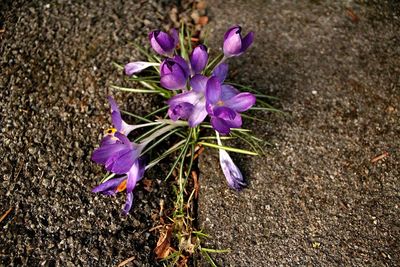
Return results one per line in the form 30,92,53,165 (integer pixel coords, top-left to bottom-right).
206,76,256,135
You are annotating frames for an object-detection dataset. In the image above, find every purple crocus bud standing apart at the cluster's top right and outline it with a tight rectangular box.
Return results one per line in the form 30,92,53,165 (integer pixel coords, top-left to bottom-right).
223,26,254,57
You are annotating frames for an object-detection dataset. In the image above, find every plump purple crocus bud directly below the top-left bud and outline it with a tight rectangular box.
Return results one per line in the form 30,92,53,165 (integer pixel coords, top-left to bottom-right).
160,55,189,90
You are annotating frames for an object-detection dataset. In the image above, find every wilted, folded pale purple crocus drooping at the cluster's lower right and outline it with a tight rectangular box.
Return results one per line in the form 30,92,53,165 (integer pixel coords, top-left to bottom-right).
219,149,246,191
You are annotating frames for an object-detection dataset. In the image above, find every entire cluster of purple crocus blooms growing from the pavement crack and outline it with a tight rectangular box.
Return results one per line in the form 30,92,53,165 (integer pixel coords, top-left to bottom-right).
92,26,256,214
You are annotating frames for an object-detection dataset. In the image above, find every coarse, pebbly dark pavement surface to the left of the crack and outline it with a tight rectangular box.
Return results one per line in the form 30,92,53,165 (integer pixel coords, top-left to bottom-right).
0,0,184,266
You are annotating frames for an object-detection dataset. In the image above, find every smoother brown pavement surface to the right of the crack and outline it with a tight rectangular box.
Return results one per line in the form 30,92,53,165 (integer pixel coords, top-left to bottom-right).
199,0,400,266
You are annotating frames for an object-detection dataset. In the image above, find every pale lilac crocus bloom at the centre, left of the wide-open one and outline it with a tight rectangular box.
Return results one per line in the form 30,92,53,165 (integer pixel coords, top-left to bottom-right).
167,74,208,127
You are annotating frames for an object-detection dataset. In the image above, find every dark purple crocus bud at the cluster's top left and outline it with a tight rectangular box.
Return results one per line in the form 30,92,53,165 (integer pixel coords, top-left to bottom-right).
149,29,179,57
